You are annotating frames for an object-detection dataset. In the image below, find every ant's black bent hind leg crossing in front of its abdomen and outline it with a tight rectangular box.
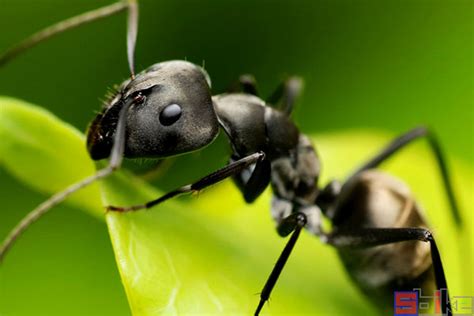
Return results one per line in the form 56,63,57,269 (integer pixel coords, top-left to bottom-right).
323,228,452,315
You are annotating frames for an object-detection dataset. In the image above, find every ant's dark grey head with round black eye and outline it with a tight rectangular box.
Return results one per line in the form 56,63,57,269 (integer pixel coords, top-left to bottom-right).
87,61,219,160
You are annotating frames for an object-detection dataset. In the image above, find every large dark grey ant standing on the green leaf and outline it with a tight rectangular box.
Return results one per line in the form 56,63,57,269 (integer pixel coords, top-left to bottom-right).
0,0,461,315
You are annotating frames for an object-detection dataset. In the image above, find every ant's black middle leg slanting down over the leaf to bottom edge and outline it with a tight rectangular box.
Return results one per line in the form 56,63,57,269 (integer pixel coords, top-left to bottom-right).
255,212,307,316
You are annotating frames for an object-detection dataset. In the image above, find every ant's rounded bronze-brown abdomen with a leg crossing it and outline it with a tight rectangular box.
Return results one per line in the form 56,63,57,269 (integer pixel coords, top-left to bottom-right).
333,170,435,310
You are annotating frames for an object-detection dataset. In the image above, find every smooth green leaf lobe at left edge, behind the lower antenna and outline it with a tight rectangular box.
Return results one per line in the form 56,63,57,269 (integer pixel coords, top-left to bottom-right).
0,97,104,217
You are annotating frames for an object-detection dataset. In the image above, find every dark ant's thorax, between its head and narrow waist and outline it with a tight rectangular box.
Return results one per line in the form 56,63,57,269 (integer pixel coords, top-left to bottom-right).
213,93,321,234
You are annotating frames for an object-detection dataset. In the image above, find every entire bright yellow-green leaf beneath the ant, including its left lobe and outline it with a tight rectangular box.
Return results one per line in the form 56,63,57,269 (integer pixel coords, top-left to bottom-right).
0,98,474,315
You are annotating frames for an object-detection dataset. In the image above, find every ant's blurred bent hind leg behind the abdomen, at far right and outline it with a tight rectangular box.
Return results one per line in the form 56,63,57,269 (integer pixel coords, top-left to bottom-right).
346,127,462,226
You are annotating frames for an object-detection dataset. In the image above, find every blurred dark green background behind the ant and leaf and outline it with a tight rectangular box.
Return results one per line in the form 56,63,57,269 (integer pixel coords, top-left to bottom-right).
0,0,474,315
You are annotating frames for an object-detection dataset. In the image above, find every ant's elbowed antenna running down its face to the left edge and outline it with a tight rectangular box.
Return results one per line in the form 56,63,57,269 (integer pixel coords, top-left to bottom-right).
0,99,134,264
